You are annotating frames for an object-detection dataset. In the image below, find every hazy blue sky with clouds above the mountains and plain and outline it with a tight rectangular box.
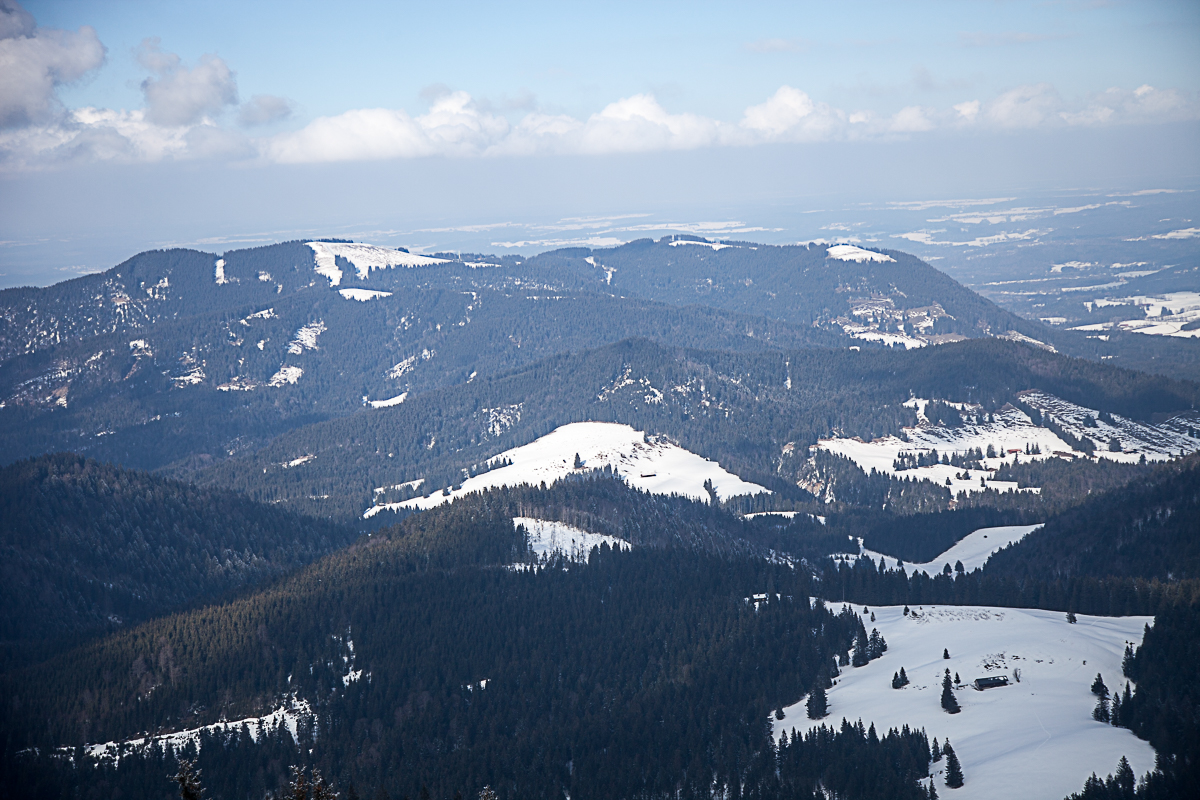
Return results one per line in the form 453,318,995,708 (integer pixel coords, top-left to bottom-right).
0,0,1200,285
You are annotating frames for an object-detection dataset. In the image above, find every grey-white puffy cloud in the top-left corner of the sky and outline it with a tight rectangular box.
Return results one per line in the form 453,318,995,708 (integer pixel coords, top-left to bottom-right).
0,0,104,128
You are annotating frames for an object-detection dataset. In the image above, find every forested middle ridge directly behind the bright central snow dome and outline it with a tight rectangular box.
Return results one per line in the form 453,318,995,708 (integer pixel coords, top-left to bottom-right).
197,339,1200,516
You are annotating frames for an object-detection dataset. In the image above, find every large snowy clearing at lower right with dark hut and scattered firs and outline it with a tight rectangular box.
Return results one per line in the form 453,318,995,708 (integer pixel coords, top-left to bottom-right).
773,606,1154,800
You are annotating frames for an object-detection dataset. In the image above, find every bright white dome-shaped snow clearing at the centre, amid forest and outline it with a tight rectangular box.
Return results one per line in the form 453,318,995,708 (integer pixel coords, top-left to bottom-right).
362,422,769,517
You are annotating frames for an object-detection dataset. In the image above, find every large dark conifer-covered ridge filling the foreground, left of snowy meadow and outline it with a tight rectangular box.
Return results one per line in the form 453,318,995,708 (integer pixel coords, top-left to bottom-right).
2,479,945,798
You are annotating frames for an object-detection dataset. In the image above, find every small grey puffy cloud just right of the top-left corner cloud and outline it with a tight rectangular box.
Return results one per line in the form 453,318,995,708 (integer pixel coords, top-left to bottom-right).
138,37,238,126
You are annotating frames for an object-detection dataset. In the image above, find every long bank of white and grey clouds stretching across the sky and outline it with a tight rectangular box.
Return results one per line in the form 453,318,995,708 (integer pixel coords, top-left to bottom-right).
0,0,1200,170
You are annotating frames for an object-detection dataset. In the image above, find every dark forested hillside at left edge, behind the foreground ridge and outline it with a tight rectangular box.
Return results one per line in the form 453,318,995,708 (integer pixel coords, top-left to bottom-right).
0,455,354,667
